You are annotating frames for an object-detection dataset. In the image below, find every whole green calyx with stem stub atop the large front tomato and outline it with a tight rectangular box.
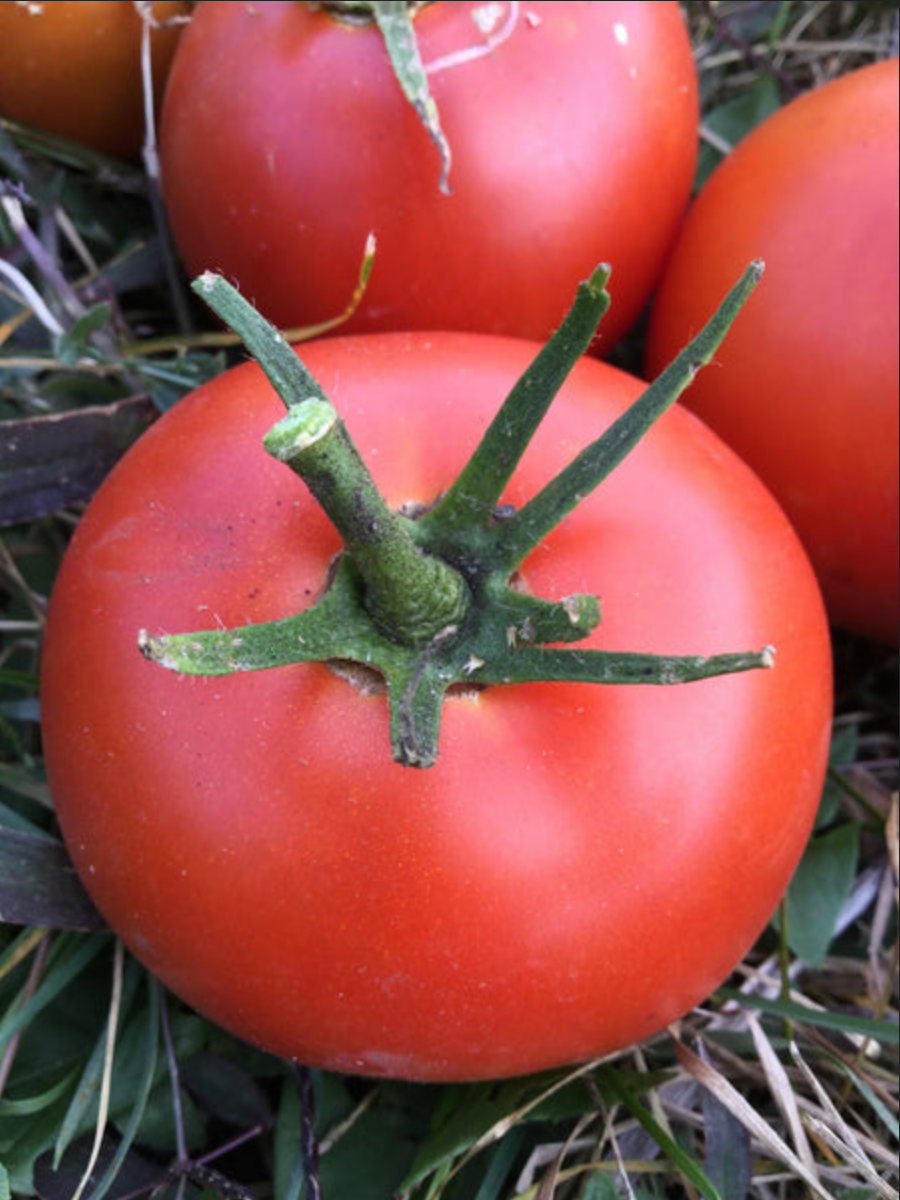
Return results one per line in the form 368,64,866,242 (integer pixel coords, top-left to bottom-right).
139,263,773,767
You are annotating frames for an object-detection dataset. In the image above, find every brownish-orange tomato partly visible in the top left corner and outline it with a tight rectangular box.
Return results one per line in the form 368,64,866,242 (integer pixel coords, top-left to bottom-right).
0,0,191,158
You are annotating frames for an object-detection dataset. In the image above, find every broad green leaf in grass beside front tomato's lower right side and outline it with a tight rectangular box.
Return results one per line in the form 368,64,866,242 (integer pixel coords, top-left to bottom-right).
779,822,859,966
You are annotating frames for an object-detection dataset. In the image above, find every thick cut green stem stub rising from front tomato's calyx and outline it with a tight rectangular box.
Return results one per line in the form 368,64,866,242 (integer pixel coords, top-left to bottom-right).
263,400,469,646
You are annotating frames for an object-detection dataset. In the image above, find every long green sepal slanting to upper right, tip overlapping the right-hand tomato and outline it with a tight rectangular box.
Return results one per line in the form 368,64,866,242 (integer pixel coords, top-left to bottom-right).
496,262,763,571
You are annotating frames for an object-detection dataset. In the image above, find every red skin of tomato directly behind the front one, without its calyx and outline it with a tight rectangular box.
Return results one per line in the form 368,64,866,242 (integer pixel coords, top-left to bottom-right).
160,0,698,349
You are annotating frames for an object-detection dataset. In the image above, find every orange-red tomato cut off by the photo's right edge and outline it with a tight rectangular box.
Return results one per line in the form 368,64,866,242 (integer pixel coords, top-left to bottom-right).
647,59,900,646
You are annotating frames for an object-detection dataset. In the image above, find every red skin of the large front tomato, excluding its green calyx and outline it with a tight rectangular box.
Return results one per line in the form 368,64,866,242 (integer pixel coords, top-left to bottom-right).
42,334,830,1080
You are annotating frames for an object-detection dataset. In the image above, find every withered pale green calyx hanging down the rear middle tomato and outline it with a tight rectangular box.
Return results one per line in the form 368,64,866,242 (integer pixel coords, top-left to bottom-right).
310,0,450,194
